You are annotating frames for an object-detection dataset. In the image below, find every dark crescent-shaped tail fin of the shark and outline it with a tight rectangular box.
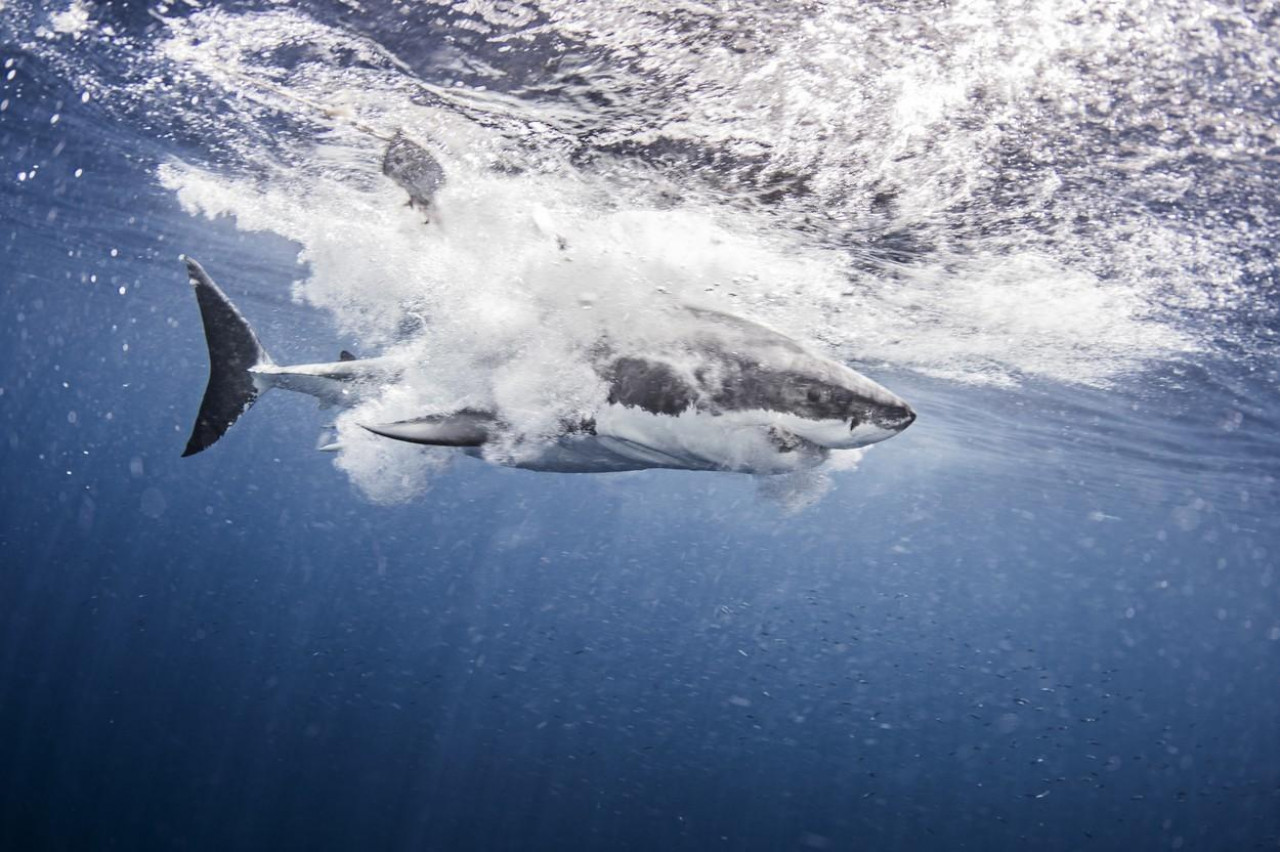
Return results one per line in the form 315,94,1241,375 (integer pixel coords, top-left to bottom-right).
182,257,271,458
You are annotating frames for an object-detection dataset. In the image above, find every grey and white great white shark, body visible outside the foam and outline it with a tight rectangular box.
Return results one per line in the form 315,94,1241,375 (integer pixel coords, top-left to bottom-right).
183,258,915,473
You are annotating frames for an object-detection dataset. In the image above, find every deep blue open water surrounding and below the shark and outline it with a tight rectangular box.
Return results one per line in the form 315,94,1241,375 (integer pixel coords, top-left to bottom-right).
0,4,1280,849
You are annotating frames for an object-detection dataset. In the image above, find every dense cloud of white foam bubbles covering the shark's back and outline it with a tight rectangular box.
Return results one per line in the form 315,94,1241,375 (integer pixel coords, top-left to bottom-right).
160,151,870,500
